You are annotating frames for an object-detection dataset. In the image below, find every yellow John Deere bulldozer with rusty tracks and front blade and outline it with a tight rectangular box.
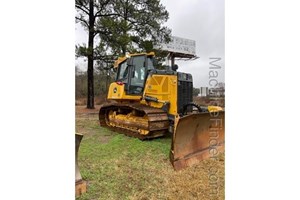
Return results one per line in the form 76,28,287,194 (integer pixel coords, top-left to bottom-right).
99,52,225,170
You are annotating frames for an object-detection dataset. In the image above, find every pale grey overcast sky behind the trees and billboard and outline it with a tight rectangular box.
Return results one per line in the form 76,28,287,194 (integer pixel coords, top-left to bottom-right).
76,0,225,87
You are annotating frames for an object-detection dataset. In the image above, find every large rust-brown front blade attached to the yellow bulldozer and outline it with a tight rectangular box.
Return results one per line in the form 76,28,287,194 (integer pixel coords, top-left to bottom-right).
170,111,225,170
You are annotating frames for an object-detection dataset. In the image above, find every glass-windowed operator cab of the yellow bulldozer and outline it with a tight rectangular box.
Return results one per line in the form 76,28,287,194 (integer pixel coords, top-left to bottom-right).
116,54,154,95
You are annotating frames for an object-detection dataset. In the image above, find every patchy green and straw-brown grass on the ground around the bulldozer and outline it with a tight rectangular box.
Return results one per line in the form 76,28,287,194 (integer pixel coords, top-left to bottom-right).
76,115,224,200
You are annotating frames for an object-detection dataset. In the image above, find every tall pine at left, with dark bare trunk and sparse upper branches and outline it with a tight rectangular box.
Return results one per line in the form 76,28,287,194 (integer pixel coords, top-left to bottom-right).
75,0,115,109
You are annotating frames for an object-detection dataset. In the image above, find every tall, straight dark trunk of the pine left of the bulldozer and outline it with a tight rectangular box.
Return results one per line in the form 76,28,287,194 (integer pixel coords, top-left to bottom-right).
86,0,95,109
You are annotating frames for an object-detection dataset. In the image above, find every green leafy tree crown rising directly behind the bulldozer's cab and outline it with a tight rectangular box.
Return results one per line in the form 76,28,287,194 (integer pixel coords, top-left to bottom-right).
97,0,171,55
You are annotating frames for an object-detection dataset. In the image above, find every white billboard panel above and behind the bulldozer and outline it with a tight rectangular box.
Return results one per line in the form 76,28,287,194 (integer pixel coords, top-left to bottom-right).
158,36,196,55
